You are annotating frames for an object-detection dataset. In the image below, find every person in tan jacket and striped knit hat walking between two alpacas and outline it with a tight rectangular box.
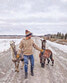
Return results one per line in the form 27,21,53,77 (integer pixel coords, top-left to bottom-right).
18,30,43,79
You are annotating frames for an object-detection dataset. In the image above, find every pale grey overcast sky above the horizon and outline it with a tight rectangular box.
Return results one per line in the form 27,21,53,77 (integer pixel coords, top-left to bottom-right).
0,0,67,35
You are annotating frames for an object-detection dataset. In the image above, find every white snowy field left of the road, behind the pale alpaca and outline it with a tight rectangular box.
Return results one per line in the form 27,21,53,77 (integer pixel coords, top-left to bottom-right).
0,39,21,52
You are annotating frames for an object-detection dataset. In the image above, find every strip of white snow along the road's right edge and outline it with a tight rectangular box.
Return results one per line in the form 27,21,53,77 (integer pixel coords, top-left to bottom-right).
47,40,67,53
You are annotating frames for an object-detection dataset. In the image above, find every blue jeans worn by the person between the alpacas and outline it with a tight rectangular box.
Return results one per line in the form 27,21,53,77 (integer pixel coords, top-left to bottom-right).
24,55,34,72
